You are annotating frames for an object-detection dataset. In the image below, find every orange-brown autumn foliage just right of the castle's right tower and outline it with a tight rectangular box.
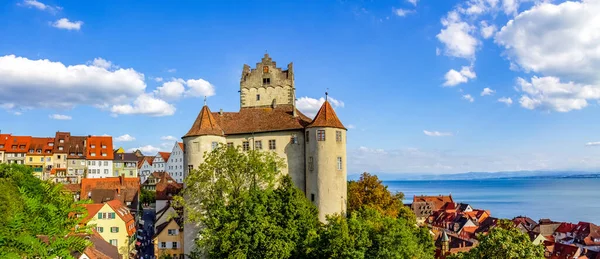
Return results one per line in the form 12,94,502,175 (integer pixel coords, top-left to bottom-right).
348,172,412,218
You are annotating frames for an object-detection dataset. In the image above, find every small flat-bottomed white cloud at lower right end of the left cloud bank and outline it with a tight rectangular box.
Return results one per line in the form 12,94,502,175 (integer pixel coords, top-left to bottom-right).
110,94,175,117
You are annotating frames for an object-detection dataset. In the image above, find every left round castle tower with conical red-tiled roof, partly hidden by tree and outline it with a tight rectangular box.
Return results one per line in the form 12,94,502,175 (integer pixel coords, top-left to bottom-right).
182,101,226,254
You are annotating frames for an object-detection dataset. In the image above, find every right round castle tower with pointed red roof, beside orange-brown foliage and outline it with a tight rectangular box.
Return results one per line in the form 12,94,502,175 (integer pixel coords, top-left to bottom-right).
305,97,347,222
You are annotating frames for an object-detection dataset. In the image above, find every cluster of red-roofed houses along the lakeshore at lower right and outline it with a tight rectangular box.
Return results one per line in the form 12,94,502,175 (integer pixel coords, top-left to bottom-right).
410,195,600,259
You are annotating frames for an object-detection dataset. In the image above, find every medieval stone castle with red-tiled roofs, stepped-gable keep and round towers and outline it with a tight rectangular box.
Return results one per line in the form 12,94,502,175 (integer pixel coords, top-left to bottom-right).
182,54,347,253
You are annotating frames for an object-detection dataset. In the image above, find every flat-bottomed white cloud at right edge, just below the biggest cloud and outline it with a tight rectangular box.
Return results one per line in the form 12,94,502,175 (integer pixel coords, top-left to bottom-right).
517,76,600,112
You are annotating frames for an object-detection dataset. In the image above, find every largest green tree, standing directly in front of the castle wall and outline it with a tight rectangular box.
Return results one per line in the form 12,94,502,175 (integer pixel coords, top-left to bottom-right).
176,146,320,258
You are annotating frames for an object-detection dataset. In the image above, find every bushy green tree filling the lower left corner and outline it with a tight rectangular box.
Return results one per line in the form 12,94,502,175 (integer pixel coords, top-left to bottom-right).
0,164,90,258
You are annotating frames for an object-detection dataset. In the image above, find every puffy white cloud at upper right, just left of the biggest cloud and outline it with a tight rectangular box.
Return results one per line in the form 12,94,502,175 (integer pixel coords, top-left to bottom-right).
436,11,479,59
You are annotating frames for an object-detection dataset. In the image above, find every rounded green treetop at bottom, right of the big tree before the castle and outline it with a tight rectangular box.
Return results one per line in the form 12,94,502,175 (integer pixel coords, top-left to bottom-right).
318,207,434,259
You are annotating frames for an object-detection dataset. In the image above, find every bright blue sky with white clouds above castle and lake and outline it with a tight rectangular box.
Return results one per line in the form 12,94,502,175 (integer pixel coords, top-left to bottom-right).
0,0,600,174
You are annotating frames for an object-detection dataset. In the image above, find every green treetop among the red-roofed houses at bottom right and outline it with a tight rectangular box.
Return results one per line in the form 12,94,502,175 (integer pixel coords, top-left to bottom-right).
454,220,544,259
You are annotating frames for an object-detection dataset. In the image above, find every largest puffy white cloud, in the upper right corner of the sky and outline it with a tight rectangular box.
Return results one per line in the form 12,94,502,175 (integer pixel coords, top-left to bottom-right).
495,1,600,85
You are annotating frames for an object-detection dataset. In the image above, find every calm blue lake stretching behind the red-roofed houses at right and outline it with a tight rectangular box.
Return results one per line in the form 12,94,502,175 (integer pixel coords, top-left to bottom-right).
384,178,600,224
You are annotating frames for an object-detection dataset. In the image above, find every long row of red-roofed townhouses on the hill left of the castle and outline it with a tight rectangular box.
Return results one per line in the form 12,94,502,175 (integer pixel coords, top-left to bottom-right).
0,132,184,183
